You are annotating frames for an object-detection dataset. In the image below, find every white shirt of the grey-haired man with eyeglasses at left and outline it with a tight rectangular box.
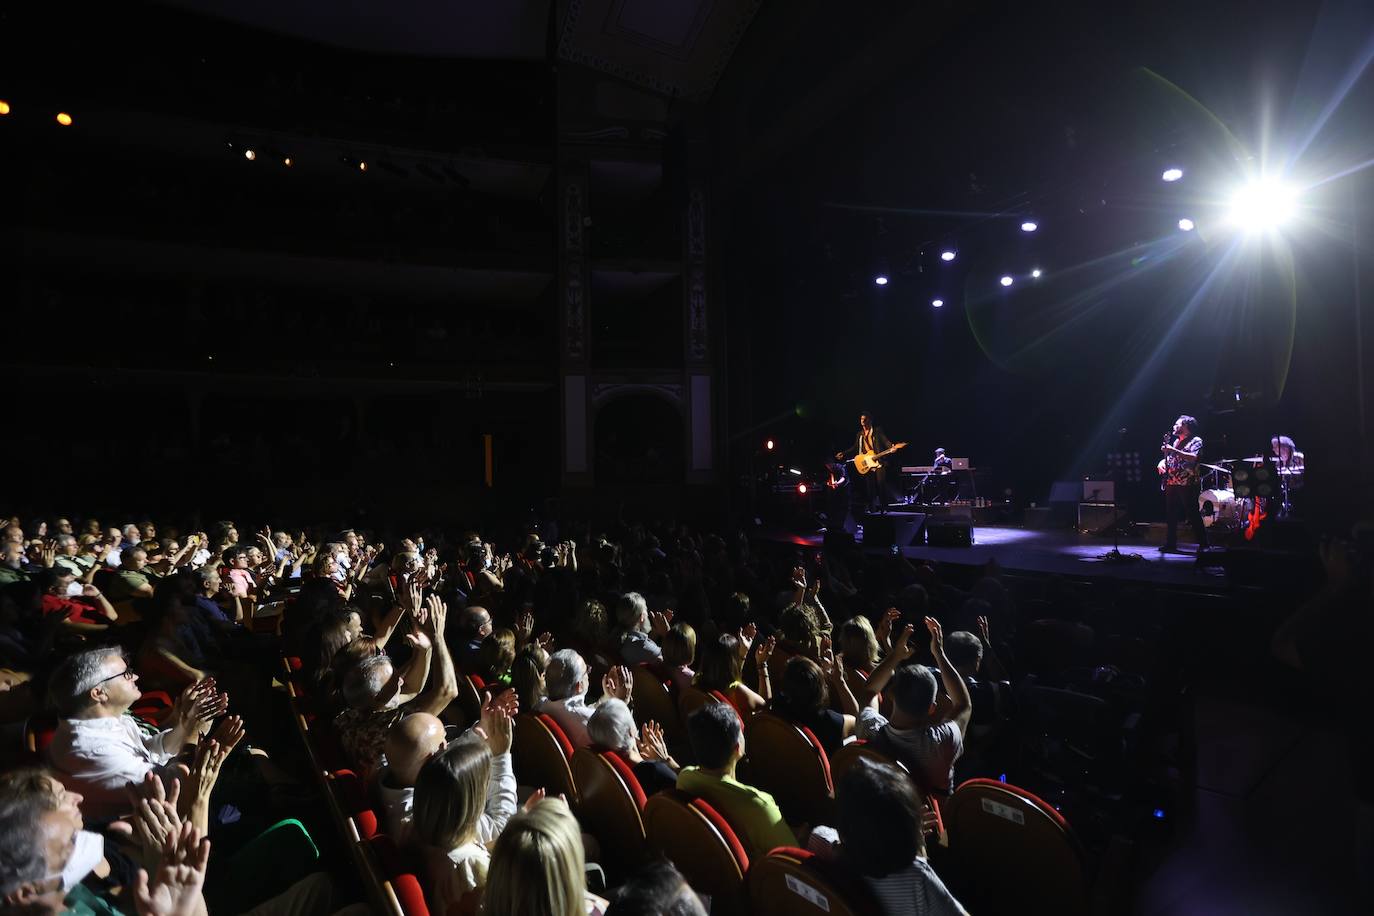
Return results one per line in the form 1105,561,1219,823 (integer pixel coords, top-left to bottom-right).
48,715,179,821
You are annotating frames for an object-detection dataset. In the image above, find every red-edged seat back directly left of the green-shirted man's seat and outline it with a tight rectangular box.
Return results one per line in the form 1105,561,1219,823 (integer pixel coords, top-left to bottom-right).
573,747,647,879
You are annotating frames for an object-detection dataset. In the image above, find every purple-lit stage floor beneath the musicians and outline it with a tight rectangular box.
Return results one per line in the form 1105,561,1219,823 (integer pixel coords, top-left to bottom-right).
765,525,1226,588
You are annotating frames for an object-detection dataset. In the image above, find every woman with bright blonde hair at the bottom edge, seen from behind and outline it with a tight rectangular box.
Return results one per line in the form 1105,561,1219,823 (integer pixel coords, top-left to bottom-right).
482,798,607,916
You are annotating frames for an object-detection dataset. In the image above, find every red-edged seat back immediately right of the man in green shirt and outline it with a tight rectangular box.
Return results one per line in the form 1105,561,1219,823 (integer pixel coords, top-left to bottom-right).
745,713,835,829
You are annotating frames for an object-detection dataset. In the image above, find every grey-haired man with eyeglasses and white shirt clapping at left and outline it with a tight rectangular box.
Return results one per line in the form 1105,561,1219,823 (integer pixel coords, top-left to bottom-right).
48,647,228,821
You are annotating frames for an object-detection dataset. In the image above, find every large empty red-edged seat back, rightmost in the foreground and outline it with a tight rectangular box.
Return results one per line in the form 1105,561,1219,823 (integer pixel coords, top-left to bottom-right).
943,779,1088,915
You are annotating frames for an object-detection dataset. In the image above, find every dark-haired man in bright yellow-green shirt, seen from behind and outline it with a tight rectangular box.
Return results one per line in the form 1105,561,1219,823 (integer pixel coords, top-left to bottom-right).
677,702,797,856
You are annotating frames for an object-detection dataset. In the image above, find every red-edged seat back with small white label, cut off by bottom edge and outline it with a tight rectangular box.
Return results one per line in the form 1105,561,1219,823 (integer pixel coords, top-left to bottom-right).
745,846,881,916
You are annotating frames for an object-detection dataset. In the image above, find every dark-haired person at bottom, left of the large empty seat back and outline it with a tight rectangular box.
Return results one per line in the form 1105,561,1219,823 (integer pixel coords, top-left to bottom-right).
835,759,969,916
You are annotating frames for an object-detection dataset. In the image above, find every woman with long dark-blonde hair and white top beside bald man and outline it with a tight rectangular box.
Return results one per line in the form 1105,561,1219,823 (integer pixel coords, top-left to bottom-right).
411,717,516,912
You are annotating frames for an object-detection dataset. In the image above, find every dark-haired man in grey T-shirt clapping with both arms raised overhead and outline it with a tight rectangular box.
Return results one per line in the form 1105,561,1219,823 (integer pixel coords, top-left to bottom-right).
859,617,973,795
